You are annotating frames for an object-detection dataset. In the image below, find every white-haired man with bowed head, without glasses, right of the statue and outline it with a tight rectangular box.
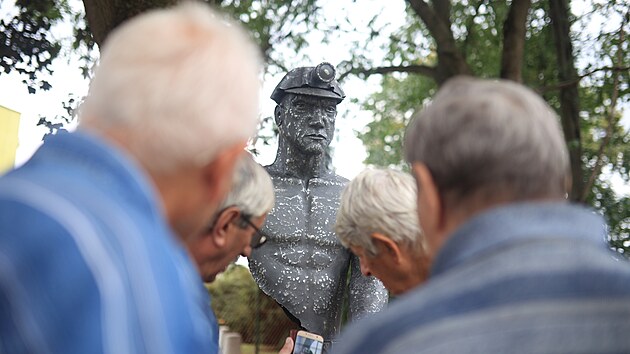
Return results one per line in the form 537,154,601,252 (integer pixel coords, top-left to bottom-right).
335,169,428,295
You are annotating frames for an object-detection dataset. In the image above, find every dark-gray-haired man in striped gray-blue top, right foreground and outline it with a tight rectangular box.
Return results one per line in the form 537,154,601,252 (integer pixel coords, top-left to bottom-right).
336,78,630,354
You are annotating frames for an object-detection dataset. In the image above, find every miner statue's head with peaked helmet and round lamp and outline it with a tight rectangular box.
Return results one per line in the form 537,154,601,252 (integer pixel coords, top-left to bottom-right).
271,62,345,155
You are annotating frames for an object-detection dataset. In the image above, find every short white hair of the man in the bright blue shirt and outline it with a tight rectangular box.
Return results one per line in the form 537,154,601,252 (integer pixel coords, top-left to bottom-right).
80,2,261,171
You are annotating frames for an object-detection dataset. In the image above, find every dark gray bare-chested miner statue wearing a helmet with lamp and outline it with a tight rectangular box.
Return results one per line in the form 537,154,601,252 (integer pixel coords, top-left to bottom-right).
249,63,388,351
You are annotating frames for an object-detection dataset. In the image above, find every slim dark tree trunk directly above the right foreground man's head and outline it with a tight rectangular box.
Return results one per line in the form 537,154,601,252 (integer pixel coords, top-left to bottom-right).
501,0,532,82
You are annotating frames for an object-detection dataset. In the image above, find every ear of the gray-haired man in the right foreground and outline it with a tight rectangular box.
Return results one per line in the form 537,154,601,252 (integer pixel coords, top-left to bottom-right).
412,162,447,253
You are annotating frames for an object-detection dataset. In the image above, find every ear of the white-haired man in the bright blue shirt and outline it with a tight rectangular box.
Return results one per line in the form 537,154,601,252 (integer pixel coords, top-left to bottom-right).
202,142,246,207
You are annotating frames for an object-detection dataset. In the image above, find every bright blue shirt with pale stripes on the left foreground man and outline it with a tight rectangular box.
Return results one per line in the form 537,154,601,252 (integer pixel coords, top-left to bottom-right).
0,133,218,354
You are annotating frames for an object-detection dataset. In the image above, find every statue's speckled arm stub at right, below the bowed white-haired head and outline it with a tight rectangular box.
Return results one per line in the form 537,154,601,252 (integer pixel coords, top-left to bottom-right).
348,255,389,321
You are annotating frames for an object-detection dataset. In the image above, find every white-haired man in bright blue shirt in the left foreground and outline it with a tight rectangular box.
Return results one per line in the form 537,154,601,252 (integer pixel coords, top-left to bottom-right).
0,3,259,354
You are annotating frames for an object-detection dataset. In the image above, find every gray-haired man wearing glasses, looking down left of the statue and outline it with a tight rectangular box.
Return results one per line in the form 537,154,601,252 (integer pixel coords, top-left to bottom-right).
186,154,274,282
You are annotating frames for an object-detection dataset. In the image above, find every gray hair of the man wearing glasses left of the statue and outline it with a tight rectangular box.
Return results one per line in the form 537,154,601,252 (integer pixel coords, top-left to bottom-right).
217,154,275,218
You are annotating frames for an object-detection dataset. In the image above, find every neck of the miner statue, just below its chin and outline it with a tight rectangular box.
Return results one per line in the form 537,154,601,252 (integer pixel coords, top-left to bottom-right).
272,140,332,180
